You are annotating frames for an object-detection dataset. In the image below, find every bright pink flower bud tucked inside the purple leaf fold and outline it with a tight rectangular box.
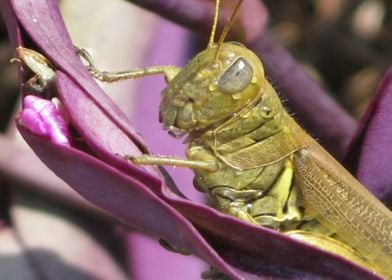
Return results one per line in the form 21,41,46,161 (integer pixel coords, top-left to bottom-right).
19,95,71,146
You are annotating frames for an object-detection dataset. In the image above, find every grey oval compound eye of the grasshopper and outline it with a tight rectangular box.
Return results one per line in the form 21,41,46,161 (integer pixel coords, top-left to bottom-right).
218,57,253,94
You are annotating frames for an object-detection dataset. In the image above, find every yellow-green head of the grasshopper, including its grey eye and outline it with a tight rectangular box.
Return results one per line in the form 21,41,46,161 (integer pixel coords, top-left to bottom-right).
160,43,265,132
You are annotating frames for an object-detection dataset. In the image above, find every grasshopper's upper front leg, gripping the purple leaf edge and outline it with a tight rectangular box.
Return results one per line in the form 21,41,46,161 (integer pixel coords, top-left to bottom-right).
75,47,181,83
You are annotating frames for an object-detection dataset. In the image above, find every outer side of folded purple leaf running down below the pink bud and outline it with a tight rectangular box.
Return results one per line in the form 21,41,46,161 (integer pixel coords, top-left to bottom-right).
19,127,245,279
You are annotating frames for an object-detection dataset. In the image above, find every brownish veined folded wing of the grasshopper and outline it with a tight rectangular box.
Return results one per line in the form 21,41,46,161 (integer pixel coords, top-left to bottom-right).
294,141,392,276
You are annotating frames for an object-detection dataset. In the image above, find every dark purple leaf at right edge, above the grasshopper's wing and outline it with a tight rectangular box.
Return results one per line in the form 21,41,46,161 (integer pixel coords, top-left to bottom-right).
346,68,392,204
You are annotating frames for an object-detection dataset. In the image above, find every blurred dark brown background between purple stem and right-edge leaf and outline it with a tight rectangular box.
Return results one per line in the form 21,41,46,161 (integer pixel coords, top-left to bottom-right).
264,0,392,118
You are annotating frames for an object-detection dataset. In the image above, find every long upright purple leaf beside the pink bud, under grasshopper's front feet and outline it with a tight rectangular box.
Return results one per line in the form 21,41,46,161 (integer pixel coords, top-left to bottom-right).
11,0,161,184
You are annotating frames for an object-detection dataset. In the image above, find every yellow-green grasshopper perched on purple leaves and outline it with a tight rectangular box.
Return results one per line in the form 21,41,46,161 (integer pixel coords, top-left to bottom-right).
79,0,392,278
